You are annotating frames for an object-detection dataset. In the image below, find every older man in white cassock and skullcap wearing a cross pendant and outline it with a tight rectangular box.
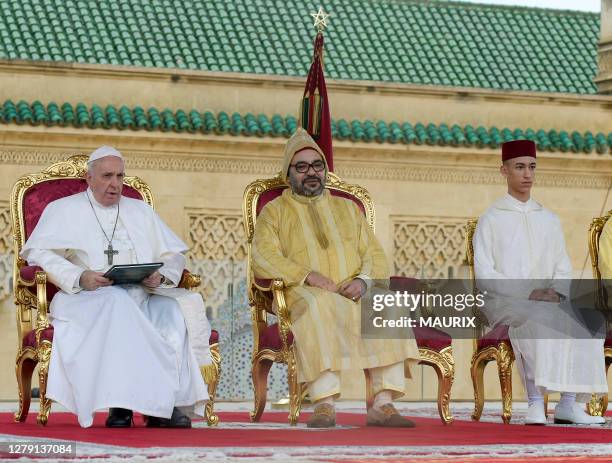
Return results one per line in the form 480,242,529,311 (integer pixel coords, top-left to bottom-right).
21,146,212,427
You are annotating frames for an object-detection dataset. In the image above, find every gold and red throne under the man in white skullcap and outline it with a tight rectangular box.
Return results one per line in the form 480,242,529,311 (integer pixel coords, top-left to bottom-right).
10,156,221,425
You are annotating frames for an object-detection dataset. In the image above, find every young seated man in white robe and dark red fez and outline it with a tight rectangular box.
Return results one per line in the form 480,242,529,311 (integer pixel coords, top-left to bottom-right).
473,140,608,424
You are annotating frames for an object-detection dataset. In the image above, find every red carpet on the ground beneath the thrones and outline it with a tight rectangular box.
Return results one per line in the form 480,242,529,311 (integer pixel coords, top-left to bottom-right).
0,412,612,448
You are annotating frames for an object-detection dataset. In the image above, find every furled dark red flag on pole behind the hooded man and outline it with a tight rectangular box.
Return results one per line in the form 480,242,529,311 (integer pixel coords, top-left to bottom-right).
300,32,334,172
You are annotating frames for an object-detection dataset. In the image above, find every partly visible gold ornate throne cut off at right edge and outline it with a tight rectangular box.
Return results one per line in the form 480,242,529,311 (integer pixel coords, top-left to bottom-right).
587,211,612,416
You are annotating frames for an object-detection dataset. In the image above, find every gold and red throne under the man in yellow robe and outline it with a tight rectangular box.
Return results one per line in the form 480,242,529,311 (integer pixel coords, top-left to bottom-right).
243,173,455,425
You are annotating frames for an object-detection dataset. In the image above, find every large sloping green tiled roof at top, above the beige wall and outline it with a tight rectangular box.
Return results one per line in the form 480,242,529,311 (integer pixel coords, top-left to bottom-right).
0,0,599,93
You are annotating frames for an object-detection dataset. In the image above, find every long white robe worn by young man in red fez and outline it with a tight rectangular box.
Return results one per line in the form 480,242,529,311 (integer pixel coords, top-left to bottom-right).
473,194,608,401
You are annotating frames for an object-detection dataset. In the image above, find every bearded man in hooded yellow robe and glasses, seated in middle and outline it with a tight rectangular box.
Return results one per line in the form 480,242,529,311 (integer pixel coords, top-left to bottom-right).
252,129,419,427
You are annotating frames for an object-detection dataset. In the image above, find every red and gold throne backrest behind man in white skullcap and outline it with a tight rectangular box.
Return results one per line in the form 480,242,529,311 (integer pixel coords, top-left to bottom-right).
10,155,153,260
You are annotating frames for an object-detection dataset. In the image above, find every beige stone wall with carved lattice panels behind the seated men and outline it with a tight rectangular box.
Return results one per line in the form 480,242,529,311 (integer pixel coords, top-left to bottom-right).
0,62,612,406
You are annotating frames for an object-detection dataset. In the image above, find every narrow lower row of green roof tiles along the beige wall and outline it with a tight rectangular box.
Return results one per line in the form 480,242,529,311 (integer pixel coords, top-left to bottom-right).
0,100,612,154
